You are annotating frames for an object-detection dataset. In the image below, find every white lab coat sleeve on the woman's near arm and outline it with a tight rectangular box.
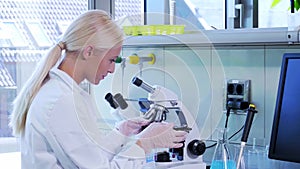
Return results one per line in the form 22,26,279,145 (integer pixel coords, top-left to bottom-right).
48,93,144,169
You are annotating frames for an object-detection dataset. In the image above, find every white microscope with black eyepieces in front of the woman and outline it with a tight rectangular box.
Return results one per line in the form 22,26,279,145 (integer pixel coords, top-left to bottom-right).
105,77,206,169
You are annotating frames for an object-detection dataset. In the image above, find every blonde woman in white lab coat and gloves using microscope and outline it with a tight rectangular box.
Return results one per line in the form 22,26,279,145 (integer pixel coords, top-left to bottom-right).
10,10,186,169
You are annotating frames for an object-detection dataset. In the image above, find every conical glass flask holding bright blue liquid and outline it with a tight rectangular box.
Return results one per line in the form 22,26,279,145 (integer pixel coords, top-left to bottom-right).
210,128,236,169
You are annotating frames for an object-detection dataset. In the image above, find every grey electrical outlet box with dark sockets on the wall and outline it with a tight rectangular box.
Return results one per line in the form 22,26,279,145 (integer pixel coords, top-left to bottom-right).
224,79,250,113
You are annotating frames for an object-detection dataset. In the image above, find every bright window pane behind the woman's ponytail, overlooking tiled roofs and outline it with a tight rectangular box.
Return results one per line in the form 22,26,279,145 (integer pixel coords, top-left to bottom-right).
0,0,88,140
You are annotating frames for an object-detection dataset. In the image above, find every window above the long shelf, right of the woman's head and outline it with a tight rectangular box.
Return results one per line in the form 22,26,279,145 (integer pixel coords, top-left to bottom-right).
114,0,290,29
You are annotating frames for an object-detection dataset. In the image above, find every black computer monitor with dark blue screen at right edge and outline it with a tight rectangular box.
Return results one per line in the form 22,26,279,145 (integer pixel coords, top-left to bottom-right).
269,53,300,163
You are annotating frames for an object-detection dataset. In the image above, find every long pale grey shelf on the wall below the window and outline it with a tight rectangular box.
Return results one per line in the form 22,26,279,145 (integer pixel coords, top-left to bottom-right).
124,28,299,47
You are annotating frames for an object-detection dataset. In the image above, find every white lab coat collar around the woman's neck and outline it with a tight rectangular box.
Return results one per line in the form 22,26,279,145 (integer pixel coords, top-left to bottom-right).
49,68,88,95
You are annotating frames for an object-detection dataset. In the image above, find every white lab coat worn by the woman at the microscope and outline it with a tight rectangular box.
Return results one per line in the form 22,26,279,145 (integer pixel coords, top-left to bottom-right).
21,68,145,169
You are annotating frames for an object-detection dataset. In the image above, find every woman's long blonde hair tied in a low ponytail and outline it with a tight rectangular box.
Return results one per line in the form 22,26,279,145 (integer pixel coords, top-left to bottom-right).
9,10,123,136
